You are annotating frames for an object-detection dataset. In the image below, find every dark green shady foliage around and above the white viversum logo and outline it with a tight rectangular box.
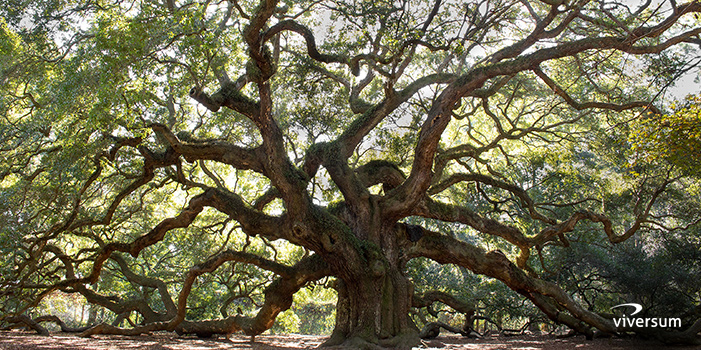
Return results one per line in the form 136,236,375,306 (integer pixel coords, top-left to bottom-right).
546,232,701,325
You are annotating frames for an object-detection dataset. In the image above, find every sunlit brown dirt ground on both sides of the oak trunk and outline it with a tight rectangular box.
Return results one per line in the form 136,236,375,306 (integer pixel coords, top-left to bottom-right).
0,331,701,350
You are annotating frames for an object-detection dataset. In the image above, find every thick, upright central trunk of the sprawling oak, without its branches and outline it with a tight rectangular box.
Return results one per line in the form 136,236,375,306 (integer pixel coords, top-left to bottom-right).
318,208,419,348
